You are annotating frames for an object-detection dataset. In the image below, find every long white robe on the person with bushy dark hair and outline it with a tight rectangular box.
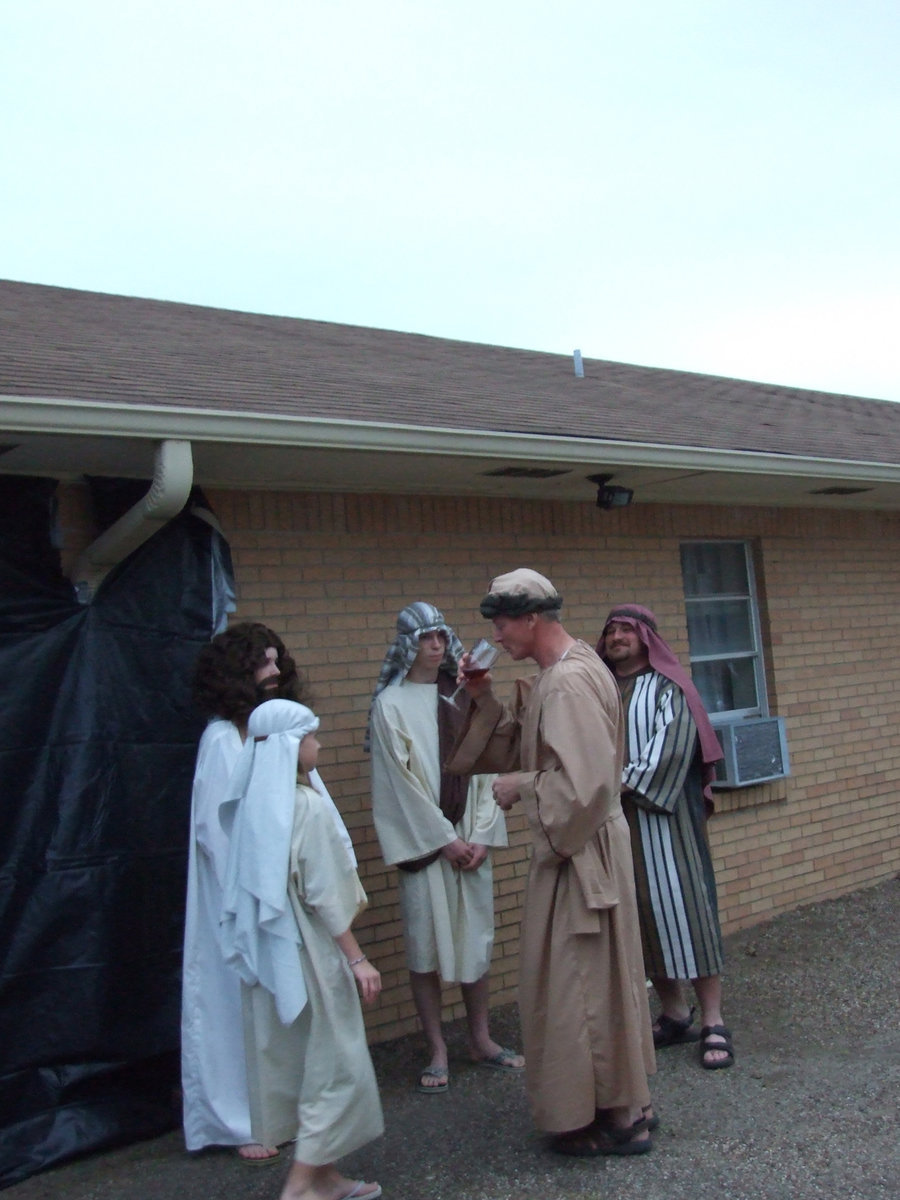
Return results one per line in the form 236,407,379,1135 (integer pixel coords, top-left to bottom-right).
181,720,252,1150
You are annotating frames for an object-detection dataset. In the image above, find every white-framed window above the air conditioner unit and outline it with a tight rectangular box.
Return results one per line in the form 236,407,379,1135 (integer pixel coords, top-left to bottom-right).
682,541,769,725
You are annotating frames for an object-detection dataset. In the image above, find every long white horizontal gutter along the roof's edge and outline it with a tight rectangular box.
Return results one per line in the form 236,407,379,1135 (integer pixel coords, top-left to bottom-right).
0,396,900,482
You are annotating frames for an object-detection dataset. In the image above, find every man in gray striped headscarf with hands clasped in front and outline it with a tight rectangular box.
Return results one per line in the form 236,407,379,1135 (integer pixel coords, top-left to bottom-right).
367,601,524,1096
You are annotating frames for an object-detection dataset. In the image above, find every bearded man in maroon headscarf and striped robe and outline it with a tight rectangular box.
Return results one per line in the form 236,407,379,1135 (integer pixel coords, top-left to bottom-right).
596,604,734,1070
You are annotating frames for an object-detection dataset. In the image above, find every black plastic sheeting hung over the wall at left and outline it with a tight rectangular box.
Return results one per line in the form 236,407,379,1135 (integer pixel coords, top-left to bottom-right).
0,479,232,1188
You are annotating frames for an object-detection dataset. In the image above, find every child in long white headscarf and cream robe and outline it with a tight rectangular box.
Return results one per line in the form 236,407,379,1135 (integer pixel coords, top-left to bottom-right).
220,700,384,1200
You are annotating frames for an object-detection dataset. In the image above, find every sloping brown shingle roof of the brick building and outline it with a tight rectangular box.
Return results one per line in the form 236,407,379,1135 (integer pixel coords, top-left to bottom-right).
0,281,900,463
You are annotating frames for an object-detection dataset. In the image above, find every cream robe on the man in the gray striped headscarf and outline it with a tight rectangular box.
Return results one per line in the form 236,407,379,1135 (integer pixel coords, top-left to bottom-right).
372,680,506,983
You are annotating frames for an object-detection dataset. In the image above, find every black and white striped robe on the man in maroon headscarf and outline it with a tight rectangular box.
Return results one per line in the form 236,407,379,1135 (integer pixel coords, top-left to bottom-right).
620,668,722,979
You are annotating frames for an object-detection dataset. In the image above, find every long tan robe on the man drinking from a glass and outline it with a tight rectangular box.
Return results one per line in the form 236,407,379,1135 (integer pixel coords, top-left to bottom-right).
450,642,655,1133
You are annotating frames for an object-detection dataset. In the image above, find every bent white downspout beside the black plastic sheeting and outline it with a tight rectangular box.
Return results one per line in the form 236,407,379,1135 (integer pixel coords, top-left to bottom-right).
71,439,193,604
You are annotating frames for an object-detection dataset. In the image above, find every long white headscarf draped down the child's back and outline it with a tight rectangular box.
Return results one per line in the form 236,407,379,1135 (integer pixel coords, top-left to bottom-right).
220,700,319,1025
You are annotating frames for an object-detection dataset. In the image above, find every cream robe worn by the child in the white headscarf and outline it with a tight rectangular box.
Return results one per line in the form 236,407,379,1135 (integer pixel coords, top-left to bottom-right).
241,785,384,1165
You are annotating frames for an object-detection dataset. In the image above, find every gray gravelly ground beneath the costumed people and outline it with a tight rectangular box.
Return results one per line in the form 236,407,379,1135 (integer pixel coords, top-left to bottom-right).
5,880,900,1200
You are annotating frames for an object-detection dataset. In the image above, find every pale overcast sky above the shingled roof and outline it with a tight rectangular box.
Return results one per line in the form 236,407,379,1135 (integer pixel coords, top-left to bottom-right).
0,0,900,401
